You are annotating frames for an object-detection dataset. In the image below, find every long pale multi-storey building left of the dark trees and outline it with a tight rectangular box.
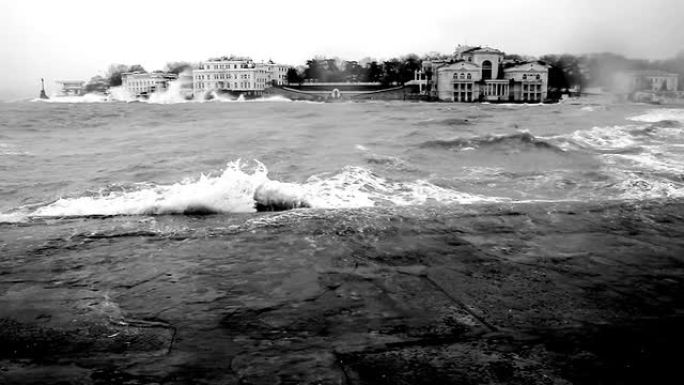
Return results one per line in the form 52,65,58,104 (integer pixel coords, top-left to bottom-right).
192,58,289,96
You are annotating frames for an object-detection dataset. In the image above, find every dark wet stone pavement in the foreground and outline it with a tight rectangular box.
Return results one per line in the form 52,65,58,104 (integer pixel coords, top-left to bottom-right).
0,201,684,384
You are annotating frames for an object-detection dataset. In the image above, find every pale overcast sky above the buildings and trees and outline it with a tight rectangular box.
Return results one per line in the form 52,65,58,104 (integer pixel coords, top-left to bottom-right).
0,0,684,100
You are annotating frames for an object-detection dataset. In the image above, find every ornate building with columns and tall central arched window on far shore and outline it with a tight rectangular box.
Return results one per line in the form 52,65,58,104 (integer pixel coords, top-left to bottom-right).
415,47,549,103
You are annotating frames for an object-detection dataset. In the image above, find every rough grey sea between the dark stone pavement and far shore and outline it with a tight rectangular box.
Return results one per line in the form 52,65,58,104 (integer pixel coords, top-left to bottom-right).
0,98,684,222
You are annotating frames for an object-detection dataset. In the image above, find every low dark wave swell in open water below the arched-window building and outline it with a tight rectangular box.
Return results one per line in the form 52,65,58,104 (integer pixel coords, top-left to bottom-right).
420,132,564,152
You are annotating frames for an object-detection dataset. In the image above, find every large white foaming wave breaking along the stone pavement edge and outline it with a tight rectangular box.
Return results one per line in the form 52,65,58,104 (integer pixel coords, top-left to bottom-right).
0,160,502,221
